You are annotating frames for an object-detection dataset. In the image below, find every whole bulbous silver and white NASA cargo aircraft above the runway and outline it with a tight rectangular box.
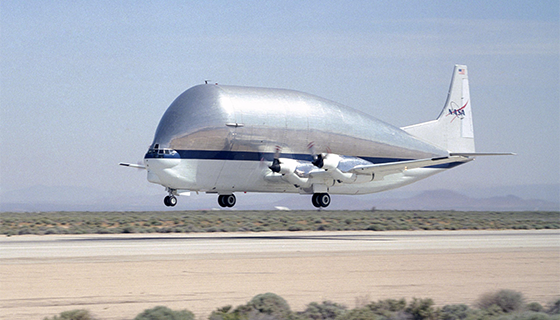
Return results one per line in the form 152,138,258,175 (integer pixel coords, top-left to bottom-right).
120,65,509,208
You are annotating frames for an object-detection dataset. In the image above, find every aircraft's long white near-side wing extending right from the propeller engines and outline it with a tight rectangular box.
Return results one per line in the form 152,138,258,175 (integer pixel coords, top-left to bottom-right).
348,155,474,176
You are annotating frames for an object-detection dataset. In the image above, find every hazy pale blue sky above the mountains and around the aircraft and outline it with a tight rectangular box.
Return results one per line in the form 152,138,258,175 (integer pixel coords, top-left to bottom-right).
0,0,560,199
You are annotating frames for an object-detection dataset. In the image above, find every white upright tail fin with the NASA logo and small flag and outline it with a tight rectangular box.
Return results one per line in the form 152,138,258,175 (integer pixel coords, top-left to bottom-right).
402,65,475,153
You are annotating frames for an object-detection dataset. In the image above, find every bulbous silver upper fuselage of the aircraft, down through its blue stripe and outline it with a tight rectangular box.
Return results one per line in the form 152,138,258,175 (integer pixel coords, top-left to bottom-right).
152,84,447,162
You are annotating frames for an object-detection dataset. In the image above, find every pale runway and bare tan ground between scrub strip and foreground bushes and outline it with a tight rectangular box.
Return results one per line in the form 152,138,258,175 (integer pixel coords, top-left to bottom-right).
0,230,560,319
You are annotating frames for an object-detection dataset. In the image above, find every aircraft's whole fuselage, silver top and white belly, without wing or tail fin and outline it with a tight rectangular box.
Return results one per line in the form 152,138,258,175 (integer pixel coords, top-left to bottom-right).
145,84,448,194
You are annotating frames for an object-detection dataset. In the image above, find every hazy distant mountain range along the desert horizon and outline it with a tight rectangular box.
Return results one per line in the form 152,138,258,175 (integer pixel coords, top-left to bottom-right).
0,184,560,212
